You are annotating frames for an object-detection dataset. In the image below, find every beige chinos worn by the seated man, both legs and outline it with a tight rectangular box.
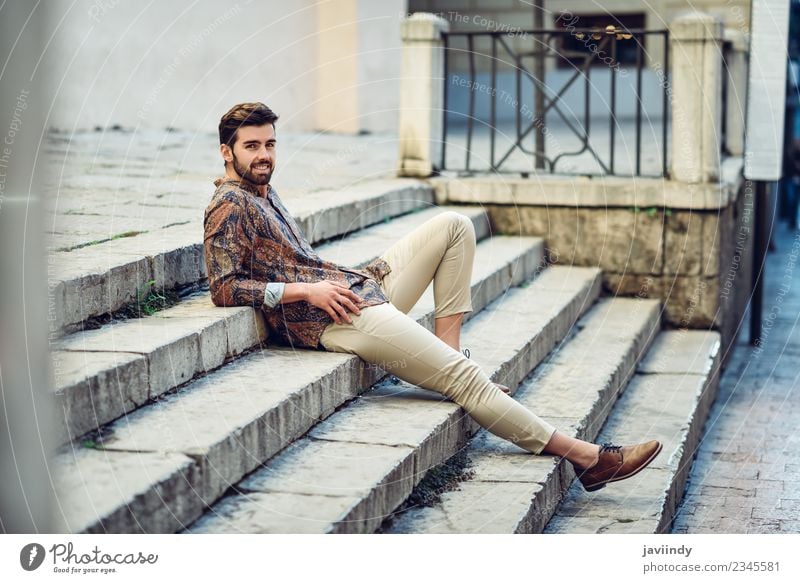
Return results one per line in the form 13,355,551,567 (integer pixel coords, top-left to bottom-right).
320,211,555,454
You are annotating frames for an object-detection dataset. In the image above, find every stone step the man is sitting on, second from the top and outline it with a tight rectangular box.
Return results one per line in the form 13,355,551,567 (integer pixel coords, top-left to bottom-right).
51,207,494,443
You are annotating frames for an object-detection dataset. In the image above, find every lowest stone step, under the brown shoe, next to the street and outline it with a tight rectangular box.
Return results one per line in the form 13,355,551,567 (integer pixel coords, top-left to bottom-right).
544,330,720,534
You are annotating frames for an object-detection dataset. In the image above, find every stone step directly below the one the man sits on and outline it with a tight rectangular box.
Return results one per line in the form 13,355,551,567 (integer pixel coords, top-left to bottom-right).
55,237,555,532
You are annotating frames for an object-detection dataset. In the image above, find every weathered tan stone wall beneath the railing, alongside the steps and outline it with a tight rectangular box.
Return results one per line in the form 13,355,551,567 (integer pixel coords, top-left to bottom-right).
439,173,754,368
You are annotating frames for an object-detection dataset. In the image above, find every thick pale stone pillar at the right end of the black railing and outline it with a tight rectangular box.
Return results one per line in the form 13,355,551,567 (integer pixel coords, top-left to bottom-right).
669,12,723,183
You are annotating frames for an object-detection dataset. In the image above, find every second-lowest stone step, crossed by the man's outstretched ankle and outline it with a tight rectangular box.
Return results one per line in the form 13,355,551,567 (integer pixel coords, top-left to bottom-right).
381,298,660,534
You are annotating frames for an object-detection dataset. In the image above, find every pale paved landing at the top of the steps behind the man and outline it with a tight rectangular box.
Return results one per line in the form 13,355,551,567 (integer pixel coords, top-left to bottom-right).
45,129,397,251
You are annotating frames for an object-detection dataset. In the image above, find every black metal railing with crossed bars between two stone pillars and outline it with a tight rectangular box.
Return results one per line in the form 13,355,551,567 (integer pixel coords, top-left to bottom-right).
440,26,670,176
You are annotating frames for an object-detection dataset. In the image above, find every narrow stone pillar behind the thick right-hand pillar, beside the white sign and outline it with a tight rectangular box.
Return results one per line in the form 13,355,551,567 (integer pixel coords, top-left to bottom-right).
725,28,749,156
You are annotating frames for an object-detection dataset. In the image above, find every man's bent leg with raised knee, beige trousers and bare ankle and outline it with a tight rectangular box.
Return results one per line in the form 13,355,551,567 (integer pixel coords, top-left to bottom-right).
381,211,475,350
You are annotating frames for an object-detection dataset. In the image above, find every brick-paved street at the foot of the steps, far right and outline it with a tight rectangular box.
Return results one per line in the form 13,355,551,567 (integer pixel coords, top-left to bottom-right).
672,224,800,533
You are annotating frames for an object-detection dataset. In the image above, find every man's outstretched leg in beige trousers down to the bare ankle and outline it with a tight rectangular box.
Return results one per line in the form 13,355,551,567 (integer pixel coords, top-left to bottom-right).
321,303,597,463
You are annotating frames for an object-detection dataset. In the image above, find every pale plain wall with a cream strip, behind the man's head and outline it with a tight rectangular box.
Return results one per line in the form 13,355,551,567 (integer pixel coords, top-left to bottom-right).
39,0,406,134
